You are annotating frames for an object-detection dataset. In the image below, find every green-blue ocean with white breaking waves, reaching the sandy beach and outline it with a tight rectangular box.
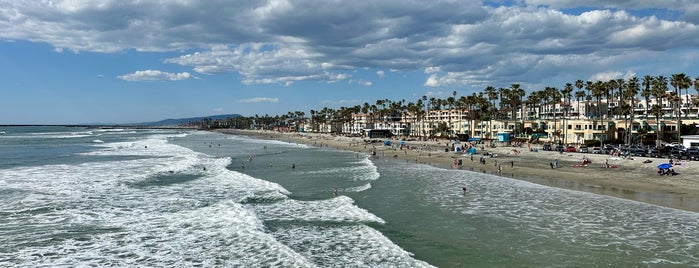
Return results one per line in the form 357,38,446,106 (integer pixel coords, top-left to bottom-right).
0,127,699,267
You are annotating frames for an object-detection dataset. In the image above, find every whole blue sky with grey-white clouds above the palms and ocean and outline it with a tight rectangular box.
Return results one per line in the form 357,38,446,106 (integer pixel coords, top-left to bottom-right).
0,0,699,124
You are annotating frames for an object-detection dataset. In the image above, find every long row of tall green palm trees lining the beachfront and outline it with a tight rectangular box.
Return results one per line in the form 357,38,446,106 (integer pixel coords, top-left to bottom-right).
208,73,699,143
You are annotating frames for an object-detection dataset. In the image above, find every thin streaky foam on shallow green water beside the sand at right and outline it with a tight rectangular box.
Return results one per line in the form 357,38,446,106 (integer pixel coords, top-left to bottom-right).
386,160,699,263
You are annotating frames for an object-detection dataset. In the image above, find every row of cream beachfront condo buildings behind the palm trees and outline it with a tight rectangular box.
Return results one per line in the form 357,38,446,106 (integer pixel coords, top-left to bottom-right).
336,95,699,144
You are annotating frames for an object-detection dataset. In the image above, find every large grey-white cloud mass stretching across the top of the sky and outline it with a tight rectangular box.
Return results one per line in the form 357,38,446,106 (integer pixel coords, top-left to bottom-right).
0,0,699,87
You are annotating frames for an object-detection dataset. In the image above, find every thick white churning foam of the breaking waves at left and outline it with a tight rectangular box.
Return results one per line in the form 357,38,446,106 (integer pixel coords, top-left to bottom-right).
0,131,426,267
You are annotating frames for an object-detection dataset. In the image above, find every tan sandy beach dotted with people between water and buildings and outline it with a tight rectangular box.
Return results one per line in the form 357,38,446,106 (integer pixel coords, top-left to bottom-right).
212,129,699,212
